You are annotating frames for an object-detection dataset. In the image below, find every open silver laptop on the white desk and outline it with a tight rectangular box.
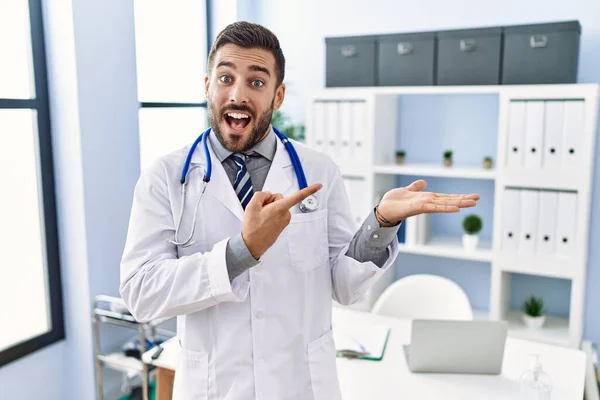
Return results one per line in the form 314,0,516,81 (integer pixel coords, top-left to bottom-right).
404,319,508,375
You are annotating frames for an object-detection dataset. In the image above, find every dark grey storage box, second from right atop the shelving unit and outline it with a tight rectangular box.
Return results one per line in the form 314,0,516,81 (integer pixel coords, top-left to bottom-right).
436,27,502,85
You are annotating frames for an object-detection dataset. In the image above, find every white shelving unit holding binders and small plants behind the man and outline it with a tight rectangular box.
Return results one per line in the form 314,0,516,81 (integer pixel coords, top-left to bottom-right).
306,84,599,347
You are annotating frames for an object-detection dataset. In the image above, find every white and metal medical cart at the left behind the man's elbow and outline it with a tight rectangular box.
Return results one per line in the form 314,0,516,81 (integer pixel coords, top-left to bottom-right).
92,295,175,400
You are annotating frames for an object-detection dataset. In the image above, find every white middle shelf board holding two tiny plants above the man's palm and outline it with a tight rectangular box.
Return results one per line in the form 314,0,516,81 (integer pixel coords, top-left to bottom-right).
373,164,496,180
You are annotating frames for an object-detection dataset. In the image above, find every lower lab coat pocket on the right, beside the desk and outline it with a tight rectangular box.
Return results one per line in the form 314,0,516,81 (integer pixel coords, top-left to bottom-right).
308,330,341,400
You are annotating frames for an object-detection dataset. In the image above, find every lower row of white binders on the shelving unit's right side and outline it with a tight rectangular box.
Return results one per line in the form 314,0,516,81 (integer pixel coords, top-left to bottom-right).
502,188,577,256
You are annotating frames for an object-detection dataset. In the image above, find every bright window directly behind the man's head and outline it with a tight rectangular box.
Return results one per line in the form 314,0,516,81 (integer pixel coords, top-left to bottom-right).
134,0,211,168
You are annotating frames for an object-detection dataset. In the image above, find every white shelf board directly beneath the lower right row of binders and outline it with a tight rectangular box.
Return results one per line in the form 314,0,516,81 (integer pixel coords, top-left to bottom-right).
495,253,580,279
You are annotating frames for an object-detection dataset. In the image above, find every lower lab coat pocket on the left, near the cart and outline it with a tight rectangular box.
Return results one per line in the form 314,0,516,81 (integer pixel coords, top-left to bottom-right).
173,348,208,400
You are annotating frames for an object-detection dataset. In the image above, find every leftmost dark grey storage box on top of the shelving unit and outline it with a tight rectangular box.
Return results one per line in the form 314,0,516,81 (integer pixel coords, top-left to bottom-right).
325,36,376,87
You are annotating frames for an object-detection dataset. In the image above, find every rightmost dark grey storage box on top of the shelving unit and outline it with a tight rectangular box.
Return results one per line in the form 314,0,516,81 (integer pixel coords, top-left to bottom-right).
502,21,581,84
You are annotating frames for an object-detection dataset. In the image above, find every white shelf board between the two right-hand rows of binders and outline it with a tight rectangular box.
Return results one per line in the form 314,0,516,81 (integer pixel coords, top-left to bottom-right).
499,168,581,190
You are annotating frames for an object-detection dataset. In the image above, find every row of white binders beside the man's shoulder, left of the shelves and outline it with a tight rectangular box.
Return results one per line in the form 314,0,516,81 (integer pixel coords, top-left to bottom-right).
313,100,367,164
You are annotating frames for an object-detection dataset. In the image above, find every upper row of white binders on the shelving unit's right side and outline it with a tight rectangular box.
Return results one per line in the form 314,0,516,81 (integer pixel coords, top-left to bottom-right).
506,100,584,169
